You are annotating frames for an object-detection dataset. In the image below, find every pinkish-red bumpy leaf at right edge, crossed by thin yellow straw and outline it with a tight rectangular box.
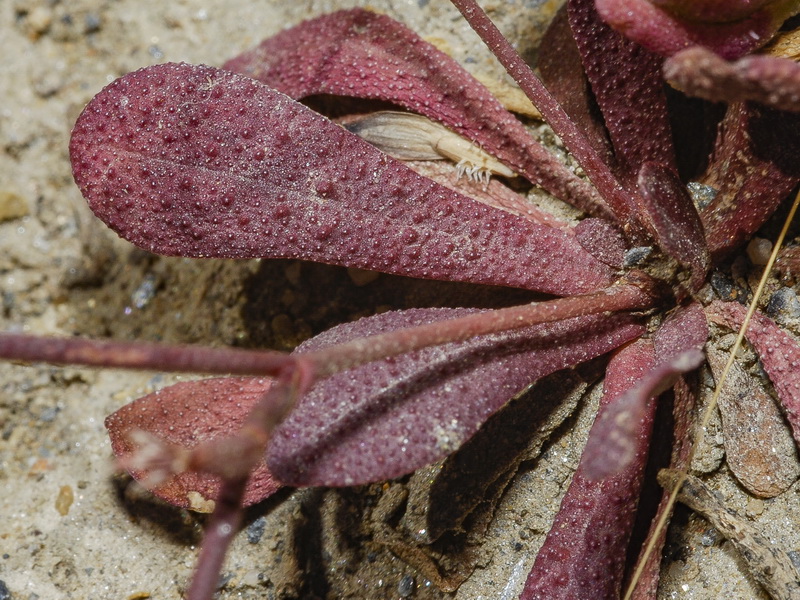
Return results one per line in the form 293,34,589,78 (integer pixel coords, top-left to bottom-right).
706,302,800,445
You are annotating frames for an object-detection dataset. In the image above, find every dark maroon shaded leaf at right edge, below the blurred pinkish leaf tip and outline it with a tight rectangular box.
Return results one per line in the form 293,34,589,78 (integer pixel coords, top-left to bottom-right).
700,102,800,259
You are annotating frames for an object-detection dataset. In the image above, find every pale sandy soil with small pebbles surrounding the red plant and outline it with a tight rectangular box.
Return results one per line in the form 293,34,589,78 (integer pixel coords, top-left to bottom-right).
0,0,800,600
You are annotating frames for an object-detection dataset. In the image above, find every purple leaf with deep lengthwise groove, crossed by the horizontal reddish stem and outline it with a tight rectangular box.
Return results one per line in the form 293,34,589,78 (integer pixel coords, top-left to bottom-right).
268,309,642,485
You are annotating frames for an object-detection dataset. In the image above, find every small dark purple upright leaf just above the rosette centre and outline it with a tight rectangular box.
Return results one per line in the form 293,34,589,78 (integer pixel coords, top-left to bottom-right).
638,162,711,292
